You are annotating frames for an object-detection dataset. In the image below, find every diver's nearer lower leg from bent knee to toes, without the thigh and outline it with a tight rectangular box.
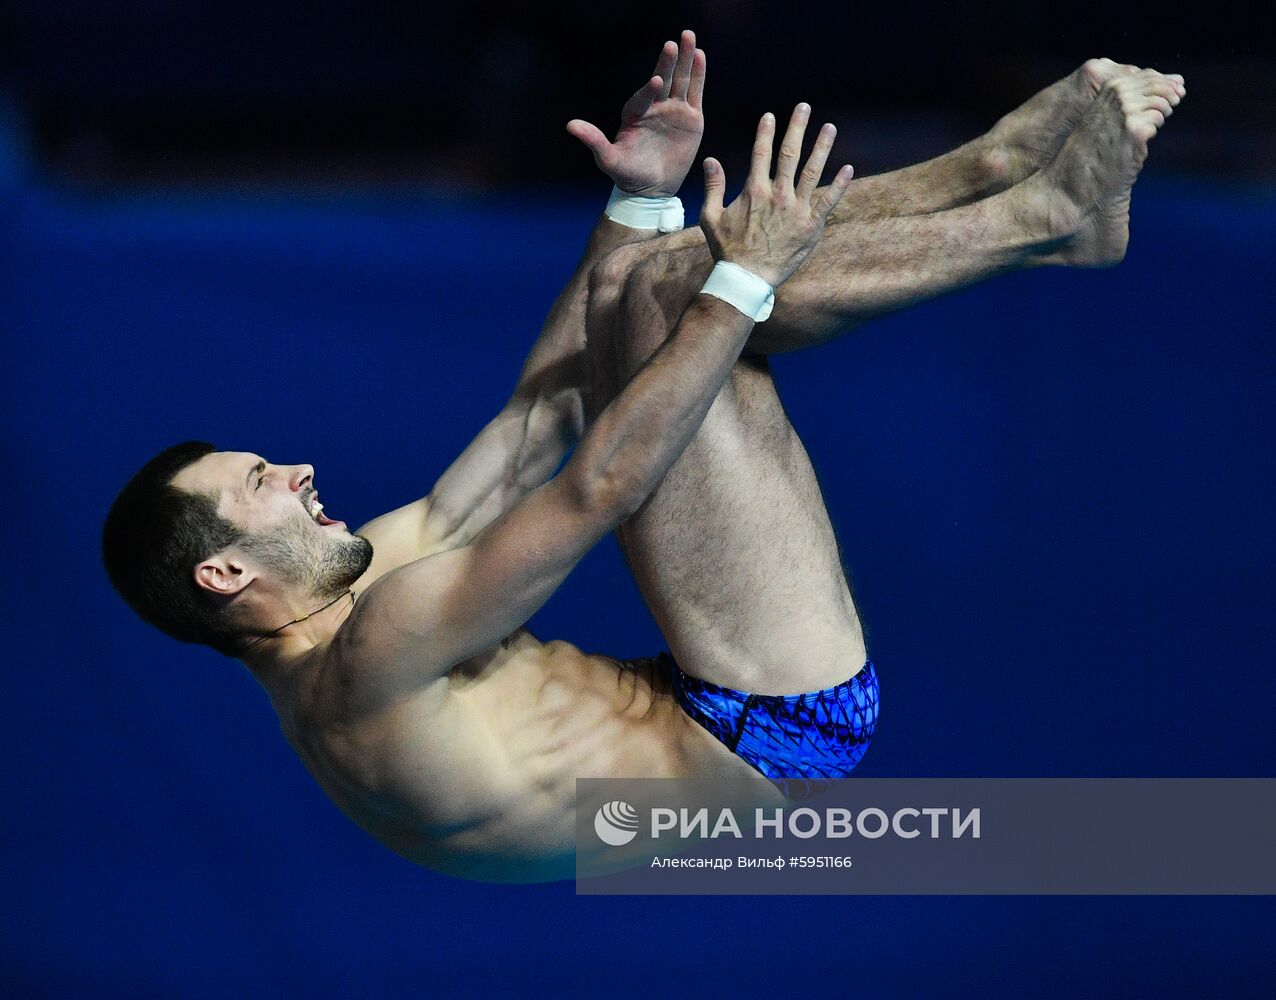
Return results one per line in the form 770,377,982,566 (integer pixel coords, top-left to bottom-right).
601,70,1179,355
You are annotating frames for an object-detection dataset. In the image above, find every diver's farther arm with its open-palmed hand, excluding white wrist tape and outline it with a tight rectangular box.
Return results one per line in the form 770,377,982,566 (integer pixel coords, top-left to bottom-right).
359,32,704,573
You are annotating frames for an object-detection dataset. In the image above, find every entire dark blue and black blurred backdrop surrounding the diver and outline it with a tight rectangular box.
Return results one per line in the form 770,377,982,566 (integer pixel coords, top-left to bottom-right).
0,0,1276,1000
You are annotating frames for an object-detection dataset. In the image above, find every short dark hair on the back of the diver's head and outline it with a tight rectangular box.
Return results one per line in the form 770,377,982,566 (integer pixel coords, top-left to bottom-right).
102,441,244,656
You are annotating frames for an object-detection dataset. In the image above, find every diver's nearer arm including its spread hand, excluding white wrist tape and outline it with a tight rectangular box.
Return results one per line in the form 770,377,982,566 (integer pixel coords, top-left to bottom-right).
347,105,850,690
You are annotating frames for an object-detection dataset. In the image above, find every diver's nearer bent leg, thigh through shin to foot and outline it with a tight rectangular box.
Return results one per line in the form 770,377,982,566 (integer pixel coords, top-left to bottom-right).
587,74,1176,694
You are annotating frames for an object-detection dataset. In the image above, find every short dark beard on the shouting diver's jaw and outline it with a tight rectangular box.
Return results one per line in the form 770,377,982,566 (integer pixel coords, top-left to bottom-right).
239,515,373,601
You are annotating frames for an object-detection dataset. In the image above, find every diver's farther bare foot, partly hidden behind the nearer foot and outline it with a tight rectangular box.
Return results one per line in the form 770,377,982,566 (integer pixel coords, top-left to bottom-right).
984,59,1185,186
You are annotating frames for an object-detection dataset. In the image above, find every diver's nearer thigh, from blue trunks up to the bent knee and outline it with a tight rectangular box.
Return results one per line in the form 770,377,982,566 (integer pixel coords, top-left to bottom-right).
591,247,865,694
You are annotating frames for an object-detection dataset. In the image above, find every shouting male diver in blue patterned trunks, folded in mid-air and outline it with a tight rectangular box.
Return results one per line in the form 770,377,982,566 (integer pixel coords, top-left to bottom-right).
103,32,1184,881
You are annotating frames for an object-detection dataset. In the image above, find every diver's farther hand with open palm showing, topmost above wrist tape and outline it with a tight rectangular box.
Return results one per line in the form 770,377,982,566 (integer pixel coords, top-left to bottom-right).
567,31,704,198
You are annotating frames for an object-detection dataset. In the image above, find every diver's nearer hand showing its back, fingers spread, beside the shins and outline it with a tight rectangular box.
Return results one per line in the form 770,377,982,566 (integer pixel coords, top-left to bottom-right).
701,105,854,287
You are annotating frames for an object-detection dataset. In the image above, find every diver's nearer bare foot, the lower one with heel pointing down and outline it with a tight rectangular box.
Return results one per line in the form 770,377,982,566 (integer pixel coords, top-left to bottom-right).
1025,70,1183,268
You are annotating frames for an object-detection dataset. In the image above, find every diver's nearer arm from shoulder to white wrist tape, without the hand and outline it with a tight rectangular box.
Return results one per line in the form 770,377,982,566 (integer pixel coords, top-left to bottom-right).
347,296,753,673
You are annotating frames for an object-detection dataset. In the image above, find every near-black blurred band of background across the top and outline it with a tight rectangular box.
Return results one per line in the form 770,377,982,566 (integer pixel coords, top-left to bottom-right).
9,0,1276,189
